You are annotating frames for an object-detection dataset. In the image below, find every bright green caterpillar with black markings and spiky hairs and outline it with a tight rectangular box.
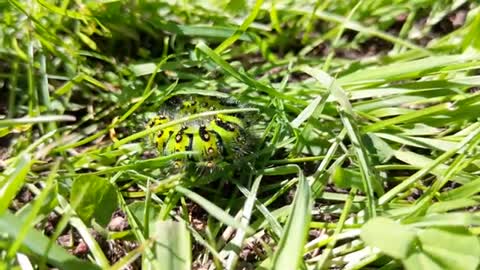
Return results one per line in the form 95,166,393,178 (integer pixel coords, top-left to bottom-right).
147,95,253,171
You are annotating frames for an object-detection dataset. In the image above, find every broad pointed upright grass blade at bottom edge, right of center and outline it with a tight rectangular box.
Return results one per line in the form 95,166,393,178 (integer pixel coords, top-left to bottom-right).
272,167,312,269
